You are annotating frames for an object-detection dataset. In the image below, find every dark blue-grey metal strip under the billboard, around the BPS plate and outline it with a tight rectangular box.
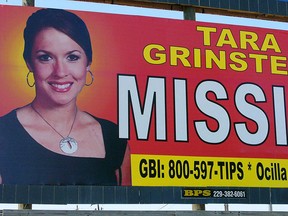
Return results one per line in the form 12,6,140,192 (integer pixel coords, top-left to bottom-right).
0,185,288,204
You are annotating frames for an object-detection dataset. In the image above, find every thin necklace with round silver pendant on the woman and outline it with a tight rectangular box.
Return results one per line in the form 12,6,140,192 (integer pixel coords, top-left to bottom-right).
31,104,78,154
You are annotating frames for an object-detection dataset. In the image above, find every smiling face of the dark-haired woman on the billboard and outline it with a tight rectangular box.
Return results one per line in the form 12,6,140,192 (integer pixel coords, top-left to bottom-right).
28,28,89,105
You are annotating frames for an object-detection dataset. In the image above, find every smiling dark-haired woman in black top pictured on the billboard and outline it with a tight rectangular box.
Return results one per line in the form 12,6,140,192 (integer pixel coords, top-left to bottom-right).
0,9,130,185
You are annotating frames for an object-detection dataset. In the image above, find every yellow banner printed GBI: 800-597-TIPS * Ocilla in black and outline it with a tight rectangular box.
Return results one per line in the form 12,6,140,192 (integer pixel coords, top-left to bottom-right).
131,154,288,188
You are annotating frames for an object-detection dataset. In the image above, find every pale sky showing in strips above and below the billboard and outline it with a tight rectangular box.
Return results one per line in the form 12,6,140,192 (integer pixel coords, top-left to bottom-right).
0,0,288,211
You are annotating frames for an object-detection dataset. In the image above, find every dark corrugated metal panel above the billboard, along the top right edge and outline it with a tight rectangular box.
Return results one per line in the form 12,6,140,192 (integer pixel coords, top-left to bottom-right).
73,0,288,21
